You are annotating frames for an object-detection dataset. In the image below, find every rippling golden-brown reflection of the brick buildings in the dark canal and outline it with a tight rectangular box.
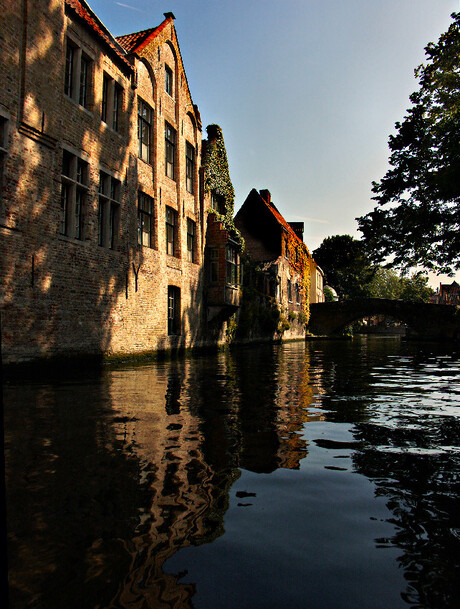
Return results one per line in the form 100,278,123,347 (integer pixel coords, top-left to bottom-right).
5,346,321,609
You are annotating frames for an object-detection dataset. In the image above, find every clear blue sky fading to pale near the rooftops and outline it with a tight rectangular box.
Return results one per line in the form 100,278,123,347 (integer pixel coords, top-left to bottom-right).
88,0,460,283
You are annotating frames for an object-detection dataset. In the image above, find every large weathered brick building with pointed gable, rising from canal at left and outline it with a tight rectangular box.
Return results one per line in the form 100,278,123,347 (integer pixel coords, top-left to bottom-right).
0,0,244,362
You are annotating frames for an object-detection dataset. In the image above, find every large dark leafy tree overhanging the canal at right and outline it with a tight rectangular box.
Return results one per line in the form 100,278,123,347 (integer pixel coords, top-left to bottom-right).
357,13,460,274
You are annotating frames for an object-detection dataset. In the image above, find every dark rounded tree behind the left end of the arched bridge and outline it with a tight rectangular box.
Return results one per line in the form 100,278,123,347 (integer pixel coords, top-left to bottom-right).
313,235,374,299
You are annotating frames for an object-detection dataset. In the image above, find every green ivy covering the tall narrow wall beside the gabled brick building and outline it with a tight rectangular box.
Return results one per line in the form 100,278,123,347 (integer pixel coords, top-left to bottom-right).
202,125,244,251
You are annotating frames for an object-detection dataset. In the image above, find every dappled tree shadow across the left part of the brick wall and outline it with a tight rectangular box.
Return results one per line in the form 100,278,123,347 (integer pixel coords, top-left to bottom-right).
0,2,142,362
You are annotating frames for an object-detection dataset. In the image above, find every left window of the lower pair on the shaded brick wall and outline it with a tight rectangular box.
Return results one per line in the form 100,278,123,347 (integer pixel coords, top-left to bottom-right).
59,150,88,239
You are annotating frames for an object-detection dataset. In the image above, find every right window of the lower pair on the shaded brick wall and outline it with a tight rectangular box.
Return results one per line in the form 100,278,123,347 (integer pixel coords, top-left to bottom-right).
98,171,121,249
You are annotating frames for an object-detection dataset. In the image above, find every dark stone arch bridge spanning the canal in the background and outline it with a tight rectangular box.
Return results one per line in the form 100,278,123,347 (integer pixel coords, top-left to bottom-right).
308,298,460,340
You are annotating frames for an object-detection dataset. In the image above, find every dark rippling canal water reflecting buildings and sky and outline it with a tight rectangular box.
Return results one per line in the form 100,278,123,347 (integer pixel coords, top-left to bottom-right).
4,338,460,609
